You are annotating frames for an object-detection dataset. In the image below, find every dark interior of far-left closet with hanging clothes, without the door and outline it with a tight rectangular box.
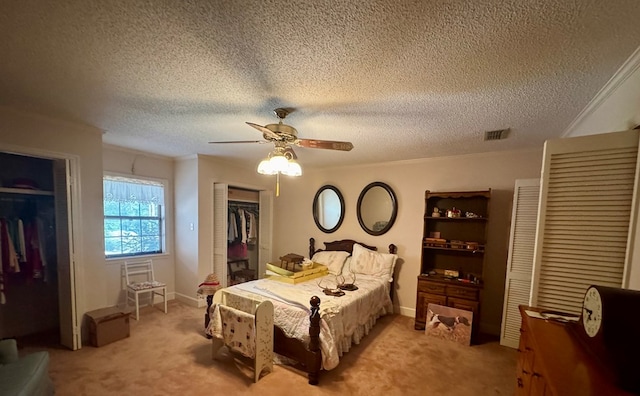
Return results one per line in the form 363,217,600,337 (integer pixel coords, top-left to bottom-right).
0,153,60,339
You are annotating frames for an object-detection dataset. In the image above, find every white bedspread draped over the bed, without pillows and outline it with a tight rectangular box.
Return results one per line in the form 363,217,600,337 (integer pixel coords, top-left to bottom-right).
207,275,393,370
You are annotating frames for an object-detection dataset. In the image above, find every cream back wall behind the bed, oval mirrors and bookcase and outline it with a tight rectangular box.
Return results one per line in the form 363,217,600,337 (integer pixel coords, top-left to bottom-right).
273,147,542,334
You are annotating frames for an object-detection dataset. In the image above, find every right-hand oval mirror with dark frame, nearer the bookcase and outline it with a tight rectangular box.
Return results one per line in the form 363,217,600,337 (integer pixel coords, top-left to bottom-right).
357,182,398,235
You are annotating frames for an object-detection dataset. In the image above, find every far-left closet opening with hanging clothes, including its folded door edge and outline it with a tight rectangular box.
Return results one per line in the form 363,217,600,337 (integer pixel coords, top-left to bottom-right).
0,151,80,350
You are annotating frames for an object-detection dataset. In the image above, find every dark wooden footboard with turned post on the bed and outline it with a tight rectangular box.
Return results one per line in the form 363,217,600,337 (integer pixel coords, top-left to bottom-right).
273,296,322,385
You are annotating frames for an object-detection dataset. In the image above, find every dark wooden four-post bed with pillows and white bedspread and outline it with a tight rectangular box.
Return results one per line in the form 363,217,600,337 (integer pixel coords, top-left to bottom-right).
207,238,397,385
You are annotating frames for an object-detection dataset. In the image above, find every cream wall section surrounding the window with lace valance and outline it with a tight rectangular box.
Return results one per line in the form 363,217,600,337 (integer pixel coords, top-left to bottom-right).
102,145,175,306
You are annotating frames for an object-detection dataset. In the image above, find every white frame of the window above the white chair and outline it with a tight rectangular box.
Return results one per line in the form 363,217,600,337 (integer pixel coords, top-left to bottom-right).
102,172,169,260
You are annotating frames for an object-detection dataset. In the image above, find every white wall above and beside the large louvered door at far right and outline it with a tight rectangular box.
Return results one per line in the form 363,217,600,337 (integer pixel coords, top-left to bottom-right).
563,47,640,290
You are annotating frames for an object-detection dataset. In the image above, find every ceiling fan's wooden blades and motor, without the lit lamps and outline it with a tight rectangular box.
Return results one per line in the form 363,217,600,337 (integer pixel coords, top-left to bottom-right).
209,107,353,156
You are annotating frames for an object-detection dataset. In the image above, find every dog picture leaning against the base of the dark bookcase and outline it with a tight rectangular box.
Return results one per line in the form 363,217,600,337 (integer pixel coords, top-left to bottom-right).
424,304,473,345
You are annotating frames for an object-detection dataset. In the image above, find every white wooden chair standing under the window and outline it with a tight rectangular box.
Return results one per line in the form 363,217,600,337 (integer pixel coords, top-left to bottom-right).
124,259,167,320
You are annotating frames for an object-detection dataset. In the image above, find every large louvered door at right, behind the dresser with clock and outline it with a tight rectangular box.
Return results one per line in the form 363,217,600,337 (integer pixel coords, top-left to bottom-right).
532,131,638,314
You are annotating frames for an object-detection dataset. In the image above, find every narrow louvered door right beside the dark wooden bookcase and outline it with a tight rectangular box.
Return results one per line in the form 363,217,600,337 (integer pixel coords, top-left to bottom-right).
500,179,540,348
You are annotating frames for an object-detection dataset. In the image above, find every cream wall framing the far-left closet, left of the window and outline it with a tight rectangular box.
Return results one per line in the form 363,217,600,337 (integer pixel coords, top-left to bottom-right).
0,108,109,321
